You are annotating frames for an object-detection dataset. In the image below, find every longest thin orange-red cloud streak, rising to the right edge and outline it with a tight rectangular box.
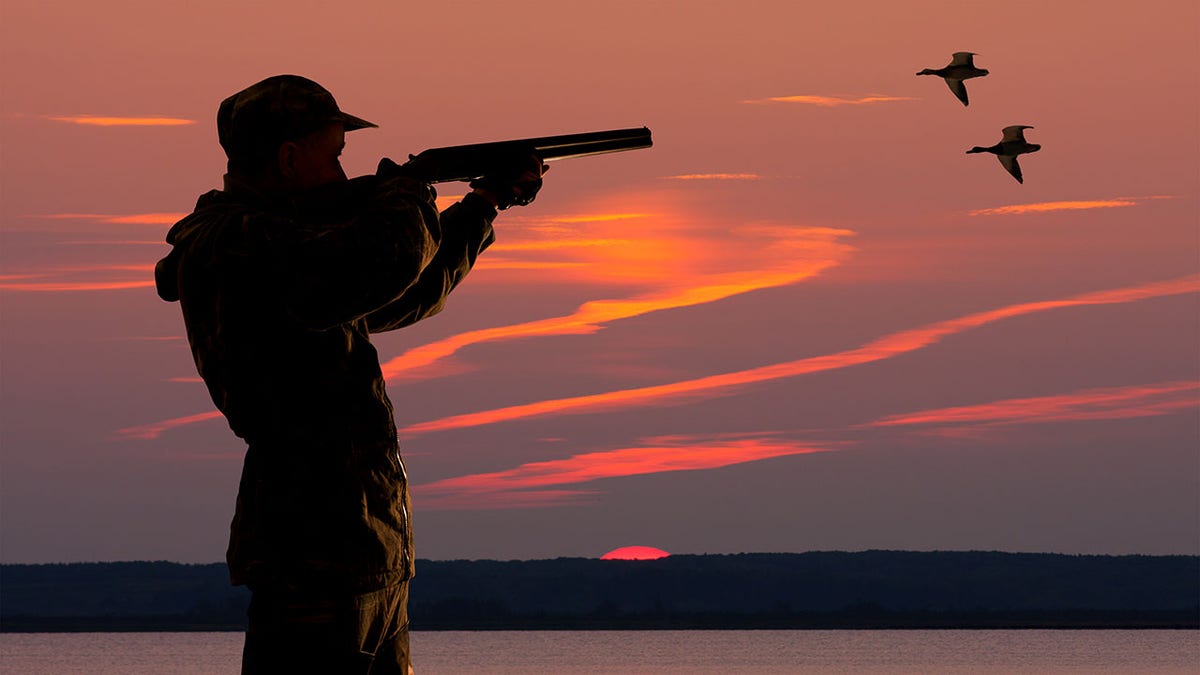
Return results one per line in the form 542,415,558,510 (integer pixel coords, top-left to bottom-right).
401,275,1200,435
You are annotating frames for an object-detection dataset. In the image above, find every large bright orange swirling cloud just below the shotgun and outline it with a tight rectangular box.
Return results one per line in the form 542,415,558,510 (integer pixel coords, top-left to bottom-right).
383,196,854,380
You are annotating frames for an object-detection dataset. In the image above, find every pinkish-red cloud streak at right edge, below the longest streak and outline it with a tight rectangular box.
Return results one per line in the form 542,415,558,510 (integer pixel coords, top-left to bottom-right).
868,381,1200,426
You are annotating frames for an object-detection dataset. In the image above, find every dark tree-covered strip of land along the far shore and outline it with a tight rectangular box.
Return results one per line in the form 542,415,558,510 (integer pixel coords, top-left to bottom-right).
0,551,1200,632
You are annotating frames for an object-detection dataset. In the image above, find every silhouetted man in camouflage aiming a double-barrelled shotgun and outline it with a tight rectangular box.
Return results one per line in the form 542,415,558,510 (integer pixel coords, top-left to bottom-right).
155,74,650,675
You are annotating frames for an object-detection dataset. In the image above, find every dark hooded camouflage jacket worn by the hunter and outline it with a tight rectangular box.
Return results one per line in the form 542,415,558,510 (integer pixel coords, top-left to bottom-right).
155,160,496,591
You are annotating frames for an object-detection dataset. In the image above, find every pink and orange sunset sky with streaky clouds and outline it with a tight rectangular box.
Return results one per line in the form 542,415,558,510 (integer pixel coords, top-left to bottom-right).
0,0,1200,562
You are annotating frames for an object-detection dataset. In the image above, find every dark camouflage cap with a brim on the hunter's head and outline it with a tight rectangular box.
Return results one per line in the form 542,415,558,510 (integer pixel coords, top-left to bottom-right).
217,74,379,160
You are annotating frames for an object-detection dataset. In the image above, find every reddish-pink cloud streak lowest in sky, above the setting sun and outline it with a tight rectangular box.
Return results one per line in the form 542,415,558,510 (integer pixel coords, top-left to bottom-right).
413,434,834,509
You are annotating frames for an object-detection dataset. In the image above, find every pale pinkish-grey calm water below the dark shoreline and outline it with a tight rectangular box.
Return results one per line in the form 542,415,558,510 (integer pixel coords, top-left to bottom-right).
0,631,1200,675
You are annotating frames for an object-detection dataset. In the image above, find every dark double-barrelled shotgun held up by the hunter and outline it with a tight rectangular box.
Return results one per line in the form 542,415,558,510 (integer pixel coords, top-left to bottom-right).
409,126,653,183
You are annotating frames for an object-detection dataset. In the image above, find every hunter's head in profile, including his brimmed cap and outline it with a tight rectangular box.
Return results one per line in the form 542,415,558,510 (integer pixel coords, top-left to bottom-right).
217,74,377,189
